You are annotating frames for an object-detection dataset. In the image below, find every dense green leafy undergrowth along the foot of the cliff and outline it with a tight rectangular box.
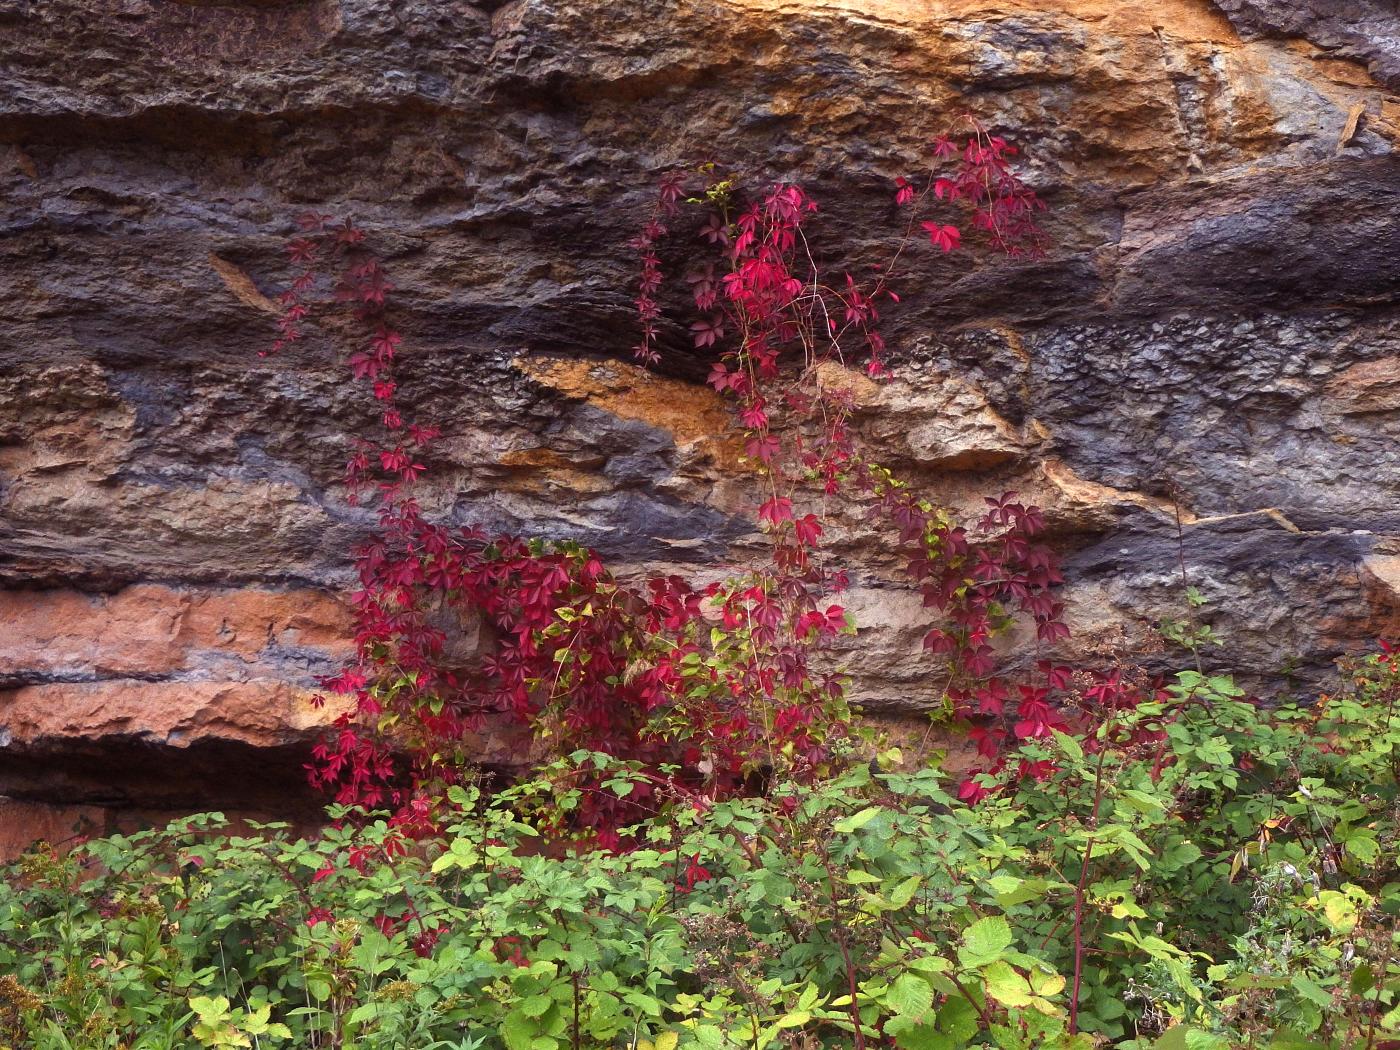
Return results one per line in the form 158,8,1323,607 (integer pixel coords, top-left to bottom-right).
0,654,1400,1050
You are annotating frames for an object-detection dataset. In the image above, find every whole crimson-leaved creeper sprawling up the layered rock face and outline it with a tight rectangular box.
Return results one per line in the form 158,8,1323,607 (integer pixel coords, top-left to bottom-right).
264,114,1136,846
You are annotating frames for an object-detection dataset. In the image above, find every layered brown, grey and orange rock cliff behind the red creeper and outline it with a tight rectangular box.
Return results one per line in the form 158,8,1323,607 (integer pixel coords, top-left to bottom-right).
0,0,1400,848
